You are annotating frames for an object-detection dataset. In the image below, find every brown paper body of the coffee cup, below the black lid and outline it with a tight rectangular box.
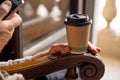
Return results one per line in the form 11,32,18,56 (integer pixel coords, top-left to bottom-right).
66,25,90,54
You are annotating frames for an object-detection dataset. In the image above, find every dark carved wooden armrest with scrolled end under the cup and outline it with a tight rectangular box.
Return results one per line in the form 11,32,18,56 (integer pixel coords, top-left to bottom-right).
0,53,104,80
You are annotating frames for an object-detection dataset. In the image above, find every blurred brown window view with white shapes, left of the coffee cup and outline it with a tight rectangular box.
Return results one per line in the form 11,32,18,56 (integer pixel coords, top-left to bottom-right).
21,0,85,56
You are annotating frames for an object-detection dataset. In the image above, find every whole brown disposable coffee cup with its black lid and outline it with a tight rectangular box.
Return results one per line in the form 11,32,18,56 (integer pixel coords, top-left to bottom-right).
65,14,92,54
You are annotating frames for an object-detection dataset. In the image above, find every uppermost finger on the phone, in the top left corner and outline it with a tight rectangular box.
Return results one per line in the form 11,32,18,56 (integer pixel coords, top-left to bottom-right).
0,0,12,20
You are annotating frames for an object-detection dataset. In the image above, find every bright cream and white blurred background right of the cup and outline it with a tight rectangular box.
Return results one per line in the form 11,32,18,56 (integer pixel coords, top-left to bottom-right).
95,0,120,80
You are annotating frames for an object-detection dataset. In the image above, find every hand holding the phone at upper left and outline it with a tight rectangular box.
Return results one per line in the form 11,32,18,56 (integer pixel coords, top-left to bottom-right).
0,0,22,51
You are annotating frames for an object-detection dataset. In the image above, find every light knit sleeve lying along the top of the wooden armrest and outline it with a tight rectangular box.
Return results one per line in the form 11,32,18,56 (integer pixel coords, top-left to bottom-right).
0,56,32,67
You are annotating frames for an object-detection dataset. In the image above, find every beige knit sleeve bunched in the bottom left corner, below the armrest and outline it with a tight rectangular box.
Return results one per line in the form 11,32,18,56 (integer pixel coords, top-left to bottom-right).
0,71,25,80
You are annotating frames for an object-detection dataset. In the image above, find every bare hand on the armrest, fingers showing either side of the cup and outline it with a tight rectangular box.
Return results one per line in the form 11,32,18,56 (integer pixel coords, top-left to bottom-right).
32,42,101,59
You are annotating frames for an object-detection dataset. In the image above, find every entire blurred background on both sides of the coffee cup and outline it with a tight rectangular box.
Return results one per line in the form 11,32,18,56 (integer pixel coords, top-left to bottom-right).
21,0,120,80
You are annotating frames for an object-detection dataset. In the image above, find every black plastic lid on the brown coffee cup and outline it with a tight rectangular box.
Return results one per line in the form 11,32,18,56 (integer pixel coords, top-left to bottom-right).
65,14,92,26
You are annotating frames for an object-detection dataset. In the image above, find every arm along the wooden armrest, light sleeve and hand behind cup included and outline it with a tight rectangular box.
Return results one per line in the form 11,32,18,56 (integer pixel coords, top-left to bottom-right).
0,42,101,66
